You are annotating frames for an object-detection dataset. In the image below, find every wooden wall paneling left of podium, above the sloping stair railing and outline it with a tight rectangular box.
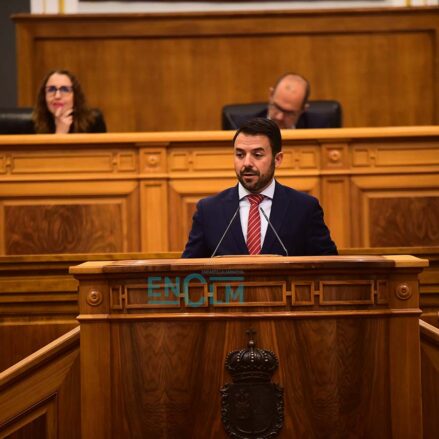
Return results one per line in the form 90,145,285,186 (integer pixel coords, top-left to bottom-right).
0,257,79,371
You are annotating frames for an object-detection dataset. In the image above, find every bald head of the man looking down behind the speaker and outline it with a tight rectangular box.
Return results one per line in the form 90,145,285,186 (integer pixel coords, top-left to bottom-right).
268,78,306,129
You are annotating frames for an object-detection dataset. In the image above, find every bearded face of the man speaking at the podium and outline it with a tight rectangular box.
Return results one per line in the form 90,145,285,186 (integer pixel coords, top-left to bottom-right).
234,133,282,193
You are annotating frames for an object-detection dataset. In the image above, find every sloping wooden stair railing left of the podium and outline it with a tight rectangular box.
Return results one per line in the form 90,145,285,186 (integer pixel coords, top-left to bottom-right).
0,327,80,439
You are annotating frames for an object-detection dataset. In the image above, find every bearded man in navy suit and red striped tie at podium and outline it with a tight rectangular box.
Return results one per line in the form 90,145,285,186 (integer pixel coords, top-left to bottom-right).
182,118,337,258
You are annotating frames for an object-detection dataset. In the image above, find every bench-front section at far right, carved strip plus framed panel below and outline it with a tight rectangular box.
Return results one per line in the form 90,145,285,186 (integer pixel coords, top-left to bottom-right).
350,139,439,247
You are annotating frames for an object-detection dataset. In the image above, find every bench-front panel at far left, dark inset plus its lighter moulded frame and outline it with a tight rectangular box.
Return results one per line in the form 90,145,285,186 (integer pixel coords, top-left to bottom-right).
1,181,139,254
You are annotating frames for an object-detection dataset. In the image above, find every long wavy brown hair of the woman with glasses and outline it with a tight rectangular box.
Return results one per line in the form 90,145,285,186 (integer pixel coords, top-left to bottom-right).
32,70,95,134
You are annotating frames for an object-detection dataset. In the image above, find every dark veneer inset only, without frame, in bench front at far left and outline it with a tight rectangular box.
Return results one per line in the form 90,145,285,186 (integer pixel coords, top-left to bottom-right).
4,203,126,255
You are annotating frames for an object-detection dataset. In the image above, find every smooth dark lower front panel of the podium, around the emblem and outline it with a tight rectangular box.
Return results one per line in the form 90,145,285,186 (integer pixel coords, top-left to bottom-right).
106,318,391,438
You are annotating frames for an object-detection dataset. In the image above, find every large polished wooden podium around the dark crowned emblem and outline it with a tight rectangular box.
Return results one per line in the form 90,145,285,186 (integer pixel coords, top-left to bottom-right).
70,256,428,439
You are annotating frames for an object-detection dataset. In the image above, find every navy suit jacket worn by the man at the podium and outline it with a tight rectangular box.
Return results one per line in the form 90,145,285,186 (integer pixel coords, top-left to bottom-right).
182,182,337,258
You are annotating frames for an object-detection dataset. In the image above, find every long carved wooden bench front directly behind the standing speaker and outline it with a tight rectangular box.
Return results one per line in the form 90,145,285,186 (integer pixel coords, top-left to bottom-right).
0,127,439,255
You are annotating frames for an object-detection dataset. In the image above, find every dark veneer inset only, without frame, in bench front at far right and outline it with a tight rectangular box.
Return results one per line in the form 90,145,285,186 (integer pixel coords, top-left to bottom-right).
369,196,439,247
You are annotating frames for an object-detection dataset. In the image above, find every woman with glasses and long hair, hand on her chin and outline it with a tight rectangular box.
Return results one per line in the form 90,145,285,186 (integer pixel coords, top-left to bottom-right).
32,70,107,134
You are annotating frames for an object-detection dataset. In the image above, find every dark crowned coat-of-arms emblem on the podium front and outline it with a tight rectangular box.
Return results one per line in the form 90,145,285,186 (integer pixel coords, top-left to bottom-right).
221,330,284,439
